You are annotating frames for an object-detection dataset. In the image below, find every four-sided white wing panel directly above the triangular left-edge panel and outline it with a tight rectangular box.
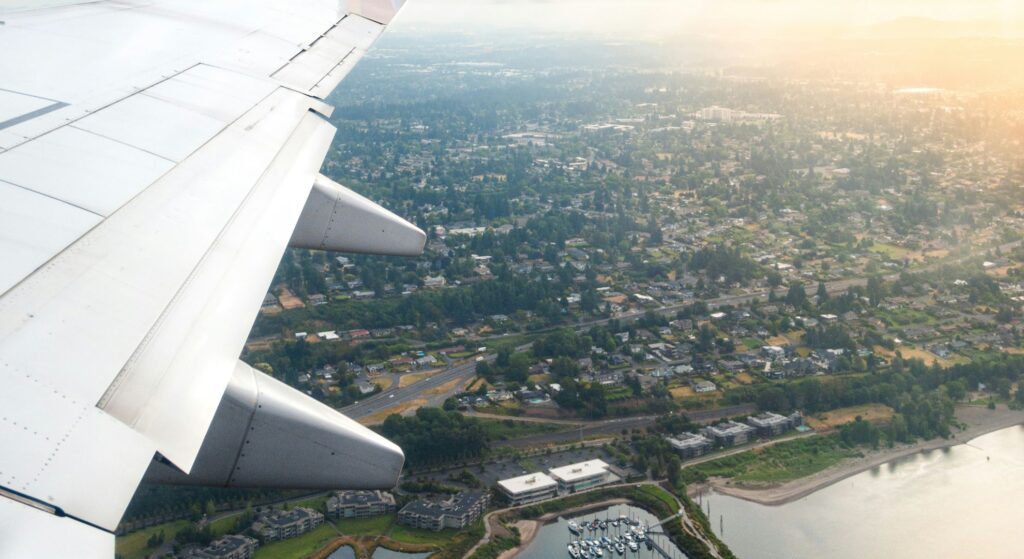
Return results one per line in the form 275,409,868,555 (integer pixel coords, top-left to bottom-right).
0,126,174,216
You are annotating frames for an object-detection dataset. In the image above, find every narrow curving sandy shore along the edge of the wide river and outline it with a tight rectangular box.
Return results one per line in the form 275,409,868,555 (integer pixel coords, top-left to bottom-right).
689,406,1024,506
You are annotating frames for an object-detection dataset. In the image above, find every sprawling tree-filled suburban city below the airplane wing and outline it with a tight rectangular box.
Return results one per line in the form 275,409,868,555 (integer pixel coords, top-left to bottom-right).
119,8,1024,557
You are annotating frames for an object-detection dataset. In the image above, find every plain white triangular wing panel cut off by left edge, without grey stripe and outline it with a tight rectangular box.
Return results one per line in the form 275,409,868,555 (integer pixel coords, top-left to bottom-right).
0,181,100,294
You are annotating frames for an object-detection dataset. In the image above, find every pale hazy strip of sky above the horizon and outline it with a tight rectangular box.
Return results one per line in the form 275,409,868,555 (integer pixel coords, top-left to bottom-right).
400,0,1024,40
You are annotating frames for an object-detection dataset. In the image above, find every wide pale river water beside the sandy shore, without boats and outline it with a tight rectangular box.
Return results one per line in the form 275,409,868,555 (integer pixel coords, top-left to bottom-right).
703,426,1024,559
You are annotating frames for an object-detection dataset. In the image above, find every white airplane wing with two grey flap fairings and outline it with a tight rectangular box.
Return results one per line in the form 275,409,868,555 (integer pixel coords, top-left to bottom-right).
0,0,425,557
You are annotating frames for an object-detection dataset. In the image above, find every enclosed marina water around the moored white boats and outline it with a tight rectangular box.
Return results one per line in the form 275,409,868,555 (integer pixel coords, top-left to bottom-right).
516,505,686,559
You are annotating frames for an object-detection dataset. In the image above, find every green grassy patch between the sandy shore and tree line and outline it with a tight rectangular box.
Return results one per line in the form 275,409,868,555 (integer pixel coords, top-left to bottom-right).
683,435,859,483
